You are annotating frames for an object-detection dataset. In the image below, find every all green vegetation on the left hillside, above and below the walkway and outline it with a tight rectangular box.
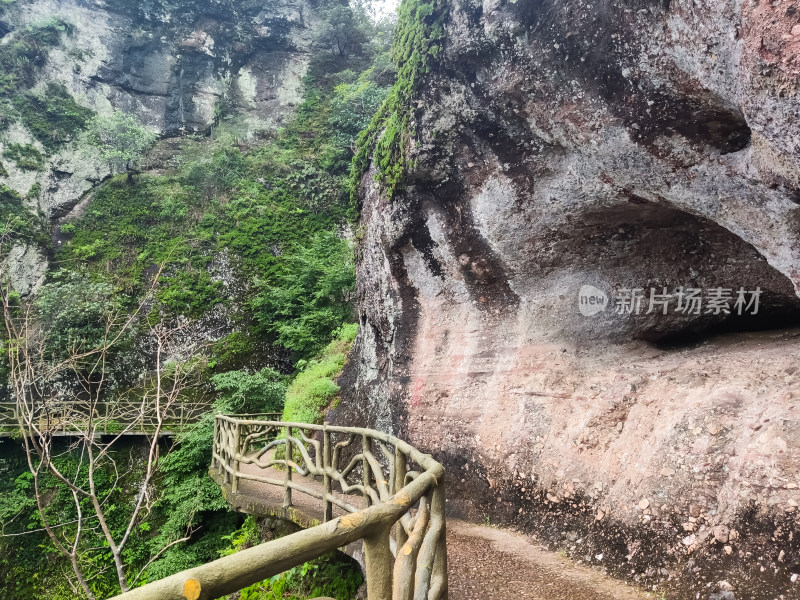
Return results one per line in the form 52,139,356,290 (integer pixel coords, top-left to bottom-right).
0,3,395,600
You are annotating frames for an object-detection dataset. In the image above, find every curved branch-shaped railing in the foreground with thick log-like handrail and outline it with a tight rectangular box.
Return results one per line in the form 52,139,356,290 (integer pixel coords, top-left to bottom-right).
111,415,447,600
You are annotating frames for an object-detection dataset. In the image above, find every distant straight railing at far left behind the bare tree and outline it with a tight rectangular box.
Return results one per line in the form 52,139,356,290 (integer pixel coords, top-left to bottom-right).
0,401,211,435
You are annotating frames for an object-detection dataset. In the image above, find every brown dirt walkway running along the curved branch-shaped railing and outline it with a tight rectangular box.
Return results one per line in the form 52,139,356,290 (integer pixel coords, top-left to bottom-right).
223,465,652,600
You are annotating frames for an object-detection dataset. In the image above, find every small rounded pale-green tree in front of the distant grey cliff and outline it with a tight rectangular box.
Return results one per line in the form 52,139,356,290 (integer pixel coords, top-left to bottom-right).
90,112,158,181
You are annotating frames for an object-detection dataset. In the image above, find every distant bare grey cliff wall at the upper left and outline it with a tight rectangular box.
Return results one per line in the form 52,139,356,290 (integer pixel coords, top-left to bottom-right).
0,0,313,217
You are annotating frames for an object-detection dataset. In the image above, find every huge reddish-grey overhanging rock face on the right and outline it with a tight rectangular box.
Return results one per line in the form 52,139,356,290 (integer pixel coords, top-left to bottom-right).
346,0,800,599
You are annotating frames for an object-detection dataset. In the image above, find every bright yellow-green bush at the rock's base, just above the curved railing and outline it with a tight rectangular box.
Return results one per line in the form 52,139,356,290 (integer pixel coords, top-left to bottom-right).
283,323,358,423
